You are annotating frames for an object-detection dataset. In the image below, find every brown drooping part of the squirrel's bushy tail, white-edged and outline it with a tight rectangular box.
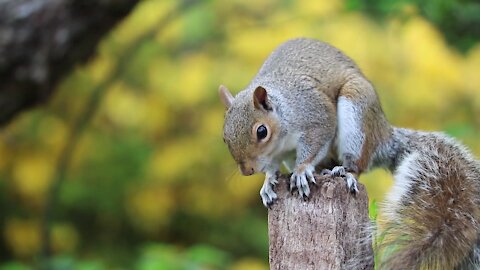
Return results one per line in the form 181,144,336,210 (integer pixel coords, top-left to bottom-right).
377,146,480,270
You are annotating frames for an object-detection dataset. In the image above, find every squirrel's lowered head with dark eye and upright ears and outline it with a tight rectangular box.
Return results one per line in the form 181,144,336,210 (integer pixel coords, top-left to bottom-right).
219,85,280,175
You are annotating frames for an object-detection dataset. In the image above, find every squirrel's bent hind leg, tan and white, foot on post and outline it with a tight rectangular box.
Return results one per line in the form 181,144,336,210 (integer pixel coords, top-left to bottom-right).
332,76,391,192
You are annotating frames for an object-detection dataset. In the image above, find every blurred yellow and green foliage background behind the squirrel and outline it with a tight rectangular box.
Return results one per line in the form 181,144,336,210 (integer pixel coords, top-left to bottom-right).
0,0,480,270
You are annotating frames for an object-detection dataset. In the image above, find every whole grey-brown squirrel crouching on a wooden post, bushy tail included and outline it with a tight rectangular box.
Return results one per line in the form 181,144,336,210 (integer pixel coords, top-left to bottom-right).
219,38,480,269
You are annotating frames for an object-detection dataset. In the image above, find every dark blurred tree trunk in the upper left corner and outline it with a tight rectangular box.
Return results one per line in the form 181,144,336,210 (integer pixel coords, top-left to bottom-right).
0,0,138,126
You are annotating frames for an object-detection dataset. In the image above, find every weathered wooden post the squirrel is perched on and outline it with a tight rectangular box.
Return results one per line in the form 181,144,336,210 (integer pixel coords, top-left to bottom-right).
268,175,374,270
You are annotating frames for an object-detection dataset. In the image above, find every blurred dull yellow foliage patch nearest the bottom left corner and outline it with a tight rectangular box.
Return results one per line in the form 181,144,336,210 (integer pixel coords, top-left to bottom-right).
3,218,40,258
